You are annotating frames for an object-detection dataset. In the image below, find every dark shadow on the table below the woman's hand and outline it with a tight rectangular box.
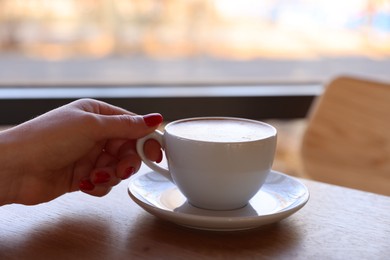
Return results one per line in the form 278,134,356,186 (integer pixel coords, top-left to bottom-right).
0,216,115,260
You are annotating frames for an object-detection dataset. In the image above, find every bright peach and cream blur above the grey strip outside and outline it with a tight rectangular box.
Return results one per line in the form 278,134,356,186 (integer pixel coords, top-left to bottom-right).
0,0,390,83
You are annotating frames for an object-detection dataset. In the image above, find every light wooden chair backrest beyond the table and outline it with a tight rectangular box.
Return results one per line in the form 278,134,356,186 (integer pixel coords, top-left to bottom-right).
301,77,390,196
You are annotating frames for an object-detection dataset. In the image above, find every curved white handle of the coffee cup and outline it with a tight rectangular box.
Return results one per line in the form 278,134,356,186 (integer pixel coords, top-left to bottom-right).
136,130,173,182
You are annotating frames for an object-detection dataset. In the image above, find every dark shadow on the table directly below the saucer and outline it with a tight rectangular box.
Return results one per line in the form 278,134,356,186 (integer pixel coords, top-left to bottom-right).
127,217,302,259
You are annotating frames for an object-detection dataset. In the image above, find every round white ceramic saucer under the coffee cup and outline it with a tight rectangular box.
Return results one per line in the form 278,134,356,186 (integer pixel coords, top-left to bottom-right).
128,171,309,231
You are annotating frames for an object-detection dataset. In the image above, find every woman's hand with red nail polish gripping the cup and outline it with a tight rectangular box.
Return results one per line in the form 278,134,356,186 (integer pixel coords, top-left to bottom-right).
0,99,163,205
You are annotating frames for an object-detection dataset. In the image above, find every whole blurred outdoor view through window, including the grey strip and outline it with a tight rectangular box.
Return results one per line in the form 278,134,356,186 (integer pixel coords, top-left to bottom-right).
0,0,390,84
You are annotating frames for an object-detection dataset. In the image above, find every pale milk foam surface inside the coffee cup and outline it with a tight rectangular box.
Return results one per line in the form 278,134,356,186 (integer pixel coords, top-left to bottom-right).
167,119,276,142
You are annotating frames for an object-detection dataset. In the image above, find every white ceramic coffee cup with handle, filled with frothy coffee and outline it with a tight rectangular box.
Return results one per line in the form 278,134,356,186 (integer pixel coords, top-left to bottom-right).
137,117,277,210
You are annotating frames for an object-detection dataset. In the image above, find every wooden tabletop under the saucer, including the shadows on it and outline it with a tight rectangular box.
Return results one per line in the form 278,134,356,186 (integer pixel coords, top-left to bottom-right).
0,168,390,259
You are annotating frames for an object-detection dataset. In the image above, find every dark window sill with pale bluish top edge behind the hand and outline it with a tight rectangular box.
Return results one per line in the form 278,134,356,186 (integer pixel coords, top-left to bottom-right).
0,84,322,125
